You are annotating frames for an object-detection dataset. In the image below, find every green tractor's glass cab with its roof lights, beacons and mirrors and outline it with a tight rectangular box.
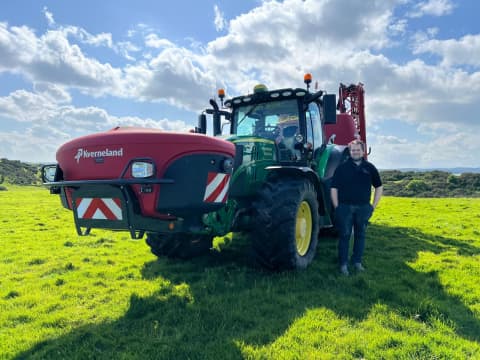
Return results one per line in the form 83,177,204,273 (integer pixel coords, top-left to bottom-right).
196,78,336,166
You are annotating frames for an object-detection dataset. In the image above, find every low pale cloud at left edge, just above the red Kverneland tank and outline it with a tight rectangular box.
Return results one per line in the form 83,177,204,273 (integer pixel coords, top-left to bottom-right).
0,84,192,162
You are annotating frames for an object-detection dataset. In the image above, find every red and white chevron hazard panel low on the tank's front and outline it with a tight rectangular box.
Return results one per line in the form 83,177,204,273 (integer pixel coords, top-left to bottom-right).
75,198,123,220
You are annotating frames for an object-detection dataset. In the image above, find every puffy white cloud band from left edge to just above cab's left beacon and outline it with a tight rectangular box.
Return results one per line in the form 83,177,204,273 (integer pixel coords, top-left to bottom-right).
0,23,215,110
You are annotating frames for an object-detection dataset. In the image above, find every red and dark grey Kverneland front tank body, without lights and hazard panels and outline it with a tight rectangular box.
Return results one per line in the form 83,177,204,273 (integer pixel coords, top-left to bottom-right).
57,128,235,217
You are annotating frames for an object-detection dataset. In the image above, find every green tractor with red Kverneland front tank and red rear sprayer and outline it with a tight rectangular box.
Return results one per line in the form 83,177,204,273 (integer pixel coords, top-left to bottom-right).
42,74,366,271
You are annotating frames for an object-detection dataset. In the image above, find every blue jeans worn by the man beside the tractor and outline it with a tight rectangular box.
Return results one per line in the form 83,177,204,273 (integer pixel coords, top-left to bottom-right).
335,204,373,266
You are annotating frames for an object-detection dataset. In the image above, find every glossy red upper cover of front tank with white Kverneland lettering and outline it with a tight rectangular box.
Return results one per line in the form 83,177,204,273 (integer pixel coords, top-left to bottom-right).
56,127,235,180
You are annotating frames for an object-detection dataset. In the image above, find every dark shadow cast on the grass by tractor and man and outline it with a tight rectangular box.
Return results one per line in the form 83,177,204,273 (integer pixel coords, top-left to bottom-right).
17,225,480,359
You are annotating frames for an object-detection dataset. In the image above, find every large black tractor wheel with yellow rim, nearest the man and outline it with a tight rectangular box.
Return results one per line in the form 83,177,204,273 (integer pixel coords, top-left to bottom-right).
252,178,319,271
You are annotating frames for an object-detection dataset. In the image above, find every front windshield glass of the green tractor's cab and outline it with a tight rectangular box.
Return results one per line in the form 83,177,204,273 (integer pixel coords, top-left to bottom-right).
233,99,299,142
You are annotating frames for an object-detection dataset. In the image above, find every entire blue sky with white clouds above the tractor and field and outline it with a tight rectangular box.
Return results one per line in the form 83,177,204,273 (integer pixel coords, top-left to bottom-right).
0,0,480,169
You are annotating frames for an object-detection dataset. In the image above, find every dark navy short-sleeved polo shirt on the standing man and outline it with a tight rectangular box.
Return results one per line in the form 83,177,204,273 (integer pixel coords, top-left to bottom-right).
332,158,382,205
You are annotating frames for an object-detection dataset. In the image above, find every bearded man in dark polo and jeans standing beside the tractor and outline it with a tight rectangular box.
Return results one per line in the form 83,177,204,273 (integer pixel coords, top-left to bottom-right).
331,140,383,276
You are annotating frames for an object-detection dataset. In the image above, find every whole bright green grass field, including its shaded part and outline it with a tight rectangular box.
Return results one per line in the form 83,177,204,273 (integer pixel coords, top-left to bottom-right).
0,187,480,359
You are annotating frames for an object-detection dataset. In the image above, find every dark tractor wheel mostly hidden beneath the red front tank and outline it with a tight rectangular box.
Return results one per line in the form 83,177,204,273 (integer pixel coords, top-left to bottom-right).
146,233,213,259
